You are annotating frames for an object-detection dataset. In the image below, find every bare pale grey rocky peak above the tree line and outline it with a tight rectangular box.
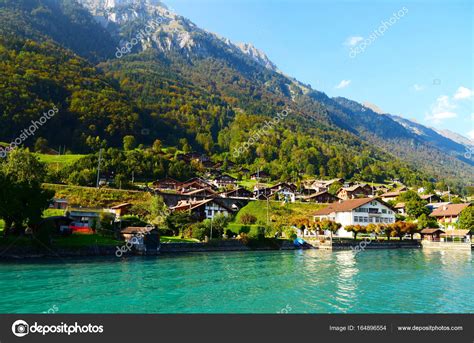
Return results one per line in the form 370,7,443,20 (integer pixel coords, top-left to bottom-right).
78,0,277,71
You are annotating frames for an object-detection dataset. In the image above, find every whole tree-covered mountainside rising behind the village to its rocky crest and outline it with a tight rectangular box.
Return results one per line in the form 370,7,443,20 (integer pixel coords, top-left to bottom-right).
0,0,473,191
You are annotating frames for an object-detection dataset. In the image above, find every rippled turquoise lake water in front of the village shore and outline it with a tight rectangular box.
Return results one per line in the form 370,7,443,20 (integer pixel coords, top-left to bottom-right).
0,249,474,313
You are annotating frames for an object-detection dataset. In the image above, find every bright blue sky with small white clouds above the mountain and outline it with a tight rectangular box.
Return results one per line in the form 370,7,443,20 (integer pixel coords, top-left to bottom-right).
164,0,474,139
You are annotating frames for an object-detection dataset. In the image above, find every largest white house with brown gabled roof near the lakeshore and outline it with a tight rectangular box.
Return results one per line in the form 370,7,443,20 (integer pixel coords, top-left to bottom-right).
313,198,395,237
